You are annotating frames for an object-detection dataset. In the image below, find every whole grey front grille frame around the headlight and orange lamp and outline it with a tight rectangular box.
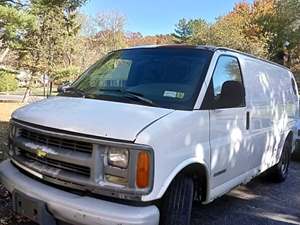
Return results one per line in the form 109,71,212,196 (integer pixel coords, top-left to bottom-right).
10,121,153,200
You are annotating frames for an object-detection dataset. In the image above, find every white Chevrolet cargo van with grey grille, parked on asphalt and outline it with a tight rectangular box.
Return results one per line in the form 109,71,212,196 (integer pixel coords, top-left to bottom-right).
0,46,298,225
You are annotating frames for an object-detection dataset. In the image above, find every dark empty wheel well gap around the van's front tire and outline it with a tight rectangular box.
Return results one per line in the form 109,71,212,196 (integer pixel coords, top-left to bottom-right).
174,163,207,201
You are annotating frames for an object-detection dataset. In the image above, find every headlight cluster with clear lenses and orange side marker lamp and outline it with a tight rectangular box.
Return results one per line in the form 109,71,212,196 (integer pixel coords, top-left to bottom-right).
104,145,154,193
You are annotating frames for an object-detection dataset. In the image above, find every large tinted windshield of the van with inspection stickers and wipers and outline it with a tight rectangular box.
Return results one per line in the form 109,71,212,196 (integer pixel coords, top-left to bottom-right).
67,48,213,110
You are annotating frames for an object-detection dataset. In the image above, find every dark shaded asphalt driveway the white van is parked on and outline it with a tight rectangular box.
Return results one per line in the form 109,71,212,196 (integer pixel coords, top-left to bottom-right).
0,162,300,225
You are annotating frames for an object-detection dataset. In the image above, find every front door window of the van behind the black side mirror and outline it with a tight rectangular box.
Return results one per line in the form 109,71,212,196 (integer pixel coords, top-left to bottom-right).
212,56,245,108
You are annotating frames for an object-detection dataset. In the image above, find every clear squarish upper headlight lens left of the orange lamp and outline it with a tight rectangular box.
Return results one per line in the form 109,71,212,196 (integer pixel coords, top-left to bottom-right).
107,148,129,169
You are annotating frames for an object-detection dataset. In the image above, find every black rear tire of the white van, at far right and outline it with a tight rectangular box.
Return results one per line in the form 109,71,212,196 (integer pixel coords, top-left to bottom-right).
270,139,292,183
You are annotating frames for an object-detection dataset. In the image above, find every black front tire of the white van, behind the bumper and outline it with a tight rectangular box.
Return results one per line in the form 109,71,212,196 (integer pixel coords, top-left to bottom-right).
160,176,194,225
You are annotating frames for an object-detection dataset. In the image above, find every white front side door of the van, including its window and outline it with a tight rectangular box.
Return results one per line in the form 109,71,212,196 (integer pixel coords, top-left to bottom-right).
209,55,252,188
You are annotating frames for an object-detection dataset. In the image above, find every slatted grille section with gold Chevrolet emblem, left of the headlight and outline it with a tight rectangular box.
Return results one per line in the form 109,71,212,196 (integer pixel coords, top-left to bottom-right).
14,127,93,182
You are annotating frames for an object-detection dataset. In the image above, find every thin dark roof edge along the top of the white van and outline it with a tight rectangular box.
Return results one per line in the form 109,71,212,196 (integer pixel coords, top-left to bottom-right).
126,44,290,70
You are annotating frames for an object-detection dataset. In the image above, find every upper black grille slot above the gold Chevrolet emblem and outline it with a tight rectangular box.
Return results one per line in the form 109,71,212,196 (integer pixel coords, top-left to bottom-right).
20,128,93,154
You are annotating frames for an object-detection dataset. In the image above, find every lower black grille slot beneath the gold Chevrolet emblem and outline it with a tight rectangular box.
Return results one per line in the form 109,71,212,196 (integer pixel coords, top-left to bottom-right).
19,148,91,177
